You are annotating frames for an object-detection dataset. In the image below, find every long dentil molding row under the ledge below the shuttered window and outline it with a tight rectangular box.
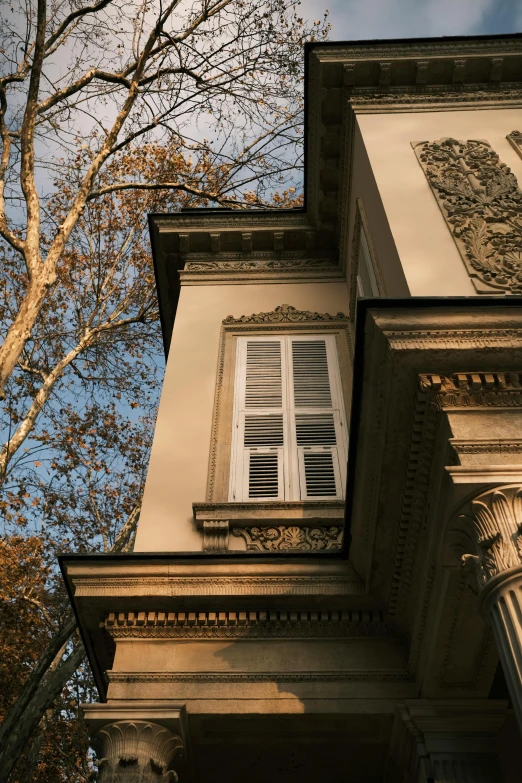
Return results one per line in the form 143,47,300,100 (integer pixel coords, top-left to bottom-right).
103,610,386,639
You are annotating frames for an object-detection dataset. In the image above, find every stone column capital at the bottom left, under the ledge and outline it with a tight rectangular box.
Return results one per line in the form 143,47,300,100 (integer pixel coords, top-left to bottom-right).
92,720,183,783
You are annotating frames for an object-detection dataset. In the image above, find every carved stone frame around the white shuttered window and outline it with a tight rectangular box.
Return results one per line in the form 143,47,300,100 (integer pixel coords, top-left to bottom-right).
206,313,353,505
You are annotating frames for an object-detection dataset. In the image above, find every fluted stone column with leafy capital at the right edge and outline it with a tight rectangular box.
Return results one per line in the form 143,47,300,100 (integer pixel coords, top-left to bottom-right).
454,484,522,730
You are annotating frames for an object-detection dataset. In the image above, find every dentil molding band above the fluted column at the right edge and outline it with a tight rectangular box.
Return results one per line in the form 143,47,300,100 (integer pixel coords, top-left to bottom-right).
419,371,522,410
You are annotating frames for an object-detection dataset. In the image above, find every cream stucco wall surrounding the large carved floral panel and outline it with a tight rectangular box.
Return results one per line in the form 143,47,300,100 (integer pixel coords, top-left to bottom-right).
357,109,522,296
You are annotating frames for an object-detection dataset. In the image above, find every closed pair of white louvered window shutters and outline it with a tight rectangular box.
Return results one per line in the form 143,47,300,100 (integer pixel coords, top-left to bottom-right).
229,334,347,502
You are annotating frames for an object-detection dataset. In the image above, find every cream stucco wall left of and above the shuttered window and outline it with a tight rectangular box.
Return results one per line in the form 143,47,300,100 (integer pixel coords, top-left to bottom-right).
135,282,348,552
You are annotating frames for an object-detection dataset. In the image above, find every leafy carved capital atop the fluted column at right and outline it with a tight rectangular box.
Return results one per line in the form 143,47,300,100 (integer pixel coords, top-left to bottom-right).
448,484,522,586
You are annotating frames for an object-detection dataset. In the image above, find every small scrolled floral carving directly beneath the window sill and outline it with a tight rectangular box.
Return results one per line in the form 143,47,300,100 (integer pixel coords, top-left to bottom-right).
232,525,343,552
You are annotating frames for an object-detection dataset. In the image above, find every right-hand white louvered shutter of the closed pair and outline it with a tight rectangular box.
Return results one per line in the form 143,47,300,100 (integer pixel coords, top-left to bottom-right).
290,335,346,500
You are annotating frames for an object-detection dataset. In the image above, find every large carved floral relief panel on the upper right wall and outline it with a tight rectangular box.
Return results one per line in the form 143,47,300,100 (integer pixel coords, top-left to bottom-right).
413,138,522,294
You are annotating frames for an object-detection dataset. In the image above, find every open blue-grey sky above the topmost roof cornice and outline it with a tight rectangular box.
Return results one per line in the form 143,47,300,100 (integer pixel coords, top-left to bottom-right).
301,0,522,41
